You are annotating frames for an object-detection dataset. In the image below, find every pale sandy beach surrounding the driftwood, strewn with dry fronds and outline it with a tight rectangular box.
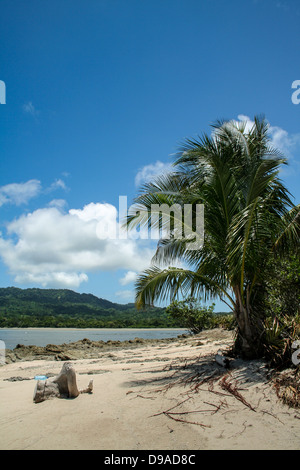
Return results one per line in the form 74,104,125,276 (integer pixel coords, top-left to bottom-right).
0,330,300,450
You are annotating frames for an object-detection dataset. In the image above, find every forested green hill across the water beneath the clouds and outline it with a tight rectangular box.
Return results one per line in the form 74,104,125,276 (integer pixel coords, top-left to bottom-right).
0,287,173,328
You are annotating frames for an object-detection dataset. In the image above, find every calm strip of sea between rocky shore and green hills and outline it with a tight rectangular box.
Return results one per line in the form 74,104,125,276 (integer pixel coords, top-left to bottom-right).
0,328,187,349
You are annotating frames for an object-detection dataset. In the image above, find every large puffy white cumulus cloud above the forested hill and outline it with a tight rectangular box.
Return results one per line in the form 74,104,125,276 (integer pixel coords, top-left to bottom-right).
0,203,153,287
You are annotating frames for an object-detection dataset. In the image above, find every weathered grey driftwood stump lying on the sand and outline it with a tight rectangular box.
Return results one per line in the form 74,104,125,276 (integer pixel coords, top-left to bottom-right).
33,362,93,403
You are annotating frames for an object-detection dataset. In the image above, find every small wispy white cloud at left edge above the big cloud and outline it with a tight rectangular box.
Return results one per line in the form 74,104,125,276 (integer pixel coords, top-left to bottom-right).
0,179,42,206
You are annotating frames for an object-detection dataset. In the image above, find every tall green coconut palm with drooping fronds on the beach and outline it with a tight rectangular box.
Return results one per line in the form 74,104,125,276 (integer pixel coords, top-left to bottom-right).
127,117,300,357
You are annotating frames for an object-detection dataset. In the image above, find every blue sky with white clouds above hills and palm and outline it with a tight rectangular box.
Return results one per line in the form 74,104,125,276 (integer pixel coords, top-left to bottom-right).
0,0,300,309
